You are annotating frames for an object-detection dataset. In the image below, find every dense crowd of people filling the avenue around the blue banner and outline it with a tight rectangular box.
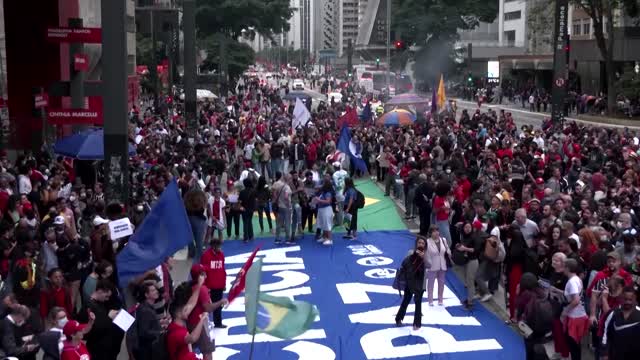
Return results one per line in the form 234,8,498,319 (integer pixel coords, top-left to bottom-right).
0,71,640,360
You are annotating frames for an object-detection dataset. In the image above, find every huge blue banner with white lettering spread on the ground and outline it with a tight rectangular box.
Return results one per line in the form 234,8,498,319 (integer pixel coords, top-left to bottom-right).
212,231,525,360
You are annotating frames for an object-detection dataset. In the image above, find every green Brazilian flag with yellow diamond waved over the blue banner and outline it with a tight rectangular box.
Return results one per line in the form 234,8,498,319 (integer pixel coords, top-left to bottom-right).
245,259,318,339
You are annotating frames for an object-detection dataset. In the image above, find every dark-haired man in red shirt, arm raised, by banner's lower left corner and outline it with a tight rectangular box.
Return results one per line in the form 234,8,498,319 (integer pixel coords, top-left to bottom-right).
166,274,211,360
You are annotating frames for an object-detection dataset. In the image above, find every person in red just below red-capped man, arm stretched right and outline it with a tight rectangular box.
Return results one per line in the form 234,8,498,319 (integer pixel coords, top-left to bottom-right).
187,264,228,360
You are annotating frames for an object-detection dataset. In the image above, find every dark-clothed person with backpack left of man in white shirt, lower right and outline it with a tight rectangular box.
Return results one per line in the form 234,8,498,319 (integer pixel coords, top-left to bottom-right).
516,273,553,360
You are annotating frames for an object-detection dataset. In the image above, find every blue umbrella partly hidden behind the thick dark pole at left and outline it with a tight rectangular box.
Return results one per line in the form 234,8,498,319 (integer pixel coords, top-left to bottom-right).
53,129,136,160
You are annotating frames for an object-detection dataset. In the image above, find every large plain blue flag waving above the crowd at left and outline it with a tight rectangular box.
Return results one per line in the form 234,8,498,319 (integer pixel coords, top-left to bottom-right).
116,180,193,287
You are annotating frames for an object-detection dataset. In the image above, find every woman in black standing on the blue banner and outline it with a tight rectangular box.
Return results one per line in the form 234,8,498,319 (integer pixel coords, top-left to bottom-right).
396,236,427,330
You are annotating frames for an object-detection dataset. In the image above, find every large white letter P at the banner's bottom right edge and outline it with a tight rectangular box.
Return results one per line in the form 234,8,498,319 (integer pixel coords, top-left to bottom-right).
360,326,502,360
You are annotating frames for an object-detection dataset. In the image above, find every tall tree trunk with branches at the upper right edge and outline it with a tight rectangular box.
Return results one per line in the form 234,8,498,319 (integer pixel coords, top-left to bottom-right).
572,0,640,114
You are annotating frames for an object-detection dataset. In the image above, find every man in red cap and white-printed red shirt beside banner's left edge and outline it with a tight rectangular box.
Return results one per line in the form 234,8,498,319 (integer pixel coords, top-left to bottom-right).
200,238,227,329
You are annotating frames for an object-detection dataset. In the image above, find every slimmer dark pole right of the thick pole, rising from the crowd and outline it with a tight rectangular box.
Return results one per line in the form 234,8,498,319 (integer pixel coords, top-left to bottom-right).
182,0,198,140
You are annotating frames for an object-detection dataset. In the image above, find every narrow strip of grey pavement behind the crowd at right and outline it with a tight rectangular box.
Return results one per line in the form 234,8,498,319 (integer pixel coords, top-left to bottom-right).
453,98,640,130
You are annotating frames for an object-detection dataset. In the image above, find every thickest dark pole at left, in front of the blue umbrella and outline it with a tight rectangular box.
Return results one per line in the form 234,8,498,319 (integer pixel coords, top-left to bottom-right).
101,0,129,206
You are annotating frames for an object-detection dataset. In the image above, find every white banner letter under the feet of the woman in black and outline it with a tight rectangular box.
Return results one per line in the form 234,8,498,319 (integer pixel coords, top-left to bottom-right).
349,299,480,326
